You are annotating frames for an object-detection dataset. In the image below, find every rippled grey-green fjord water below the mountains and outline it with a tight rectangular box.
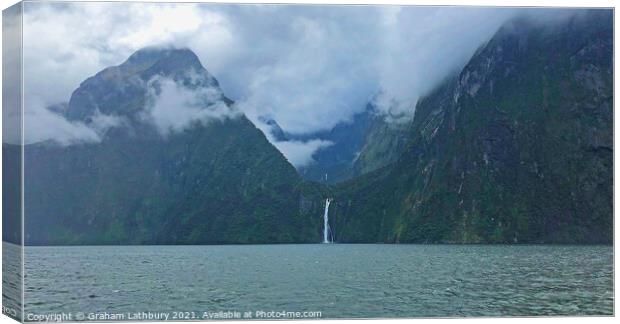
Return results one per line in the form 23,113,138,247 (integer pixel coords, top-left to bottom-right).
18,244,613,318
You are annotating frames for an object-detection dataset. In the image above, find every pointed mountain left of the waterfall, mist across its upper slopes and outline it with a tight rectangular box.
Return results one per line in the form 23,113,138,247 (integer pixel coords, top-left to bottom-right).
24,48,322,245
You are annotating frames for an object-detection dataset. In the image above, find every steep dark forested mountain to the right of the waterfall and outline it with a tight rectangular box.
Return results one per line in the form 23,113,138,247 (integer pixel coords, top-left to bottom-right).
330,10,613,244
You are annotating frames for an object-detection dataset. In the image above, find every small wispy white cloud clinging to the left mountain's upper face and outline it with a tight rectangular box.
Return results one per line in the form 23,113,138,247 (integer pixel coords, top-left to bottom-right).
142,76,241,136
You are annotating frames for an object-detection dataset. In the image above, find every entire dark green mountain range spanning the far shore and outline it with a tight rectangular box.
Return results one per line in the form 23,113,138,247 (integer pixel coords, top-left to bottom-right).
3,10,613,245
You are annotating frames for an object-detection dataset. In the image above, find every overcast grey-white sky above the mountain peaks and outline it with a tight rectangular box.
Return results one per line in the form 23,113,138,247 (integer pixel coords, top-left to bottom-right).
14,2,536,165
